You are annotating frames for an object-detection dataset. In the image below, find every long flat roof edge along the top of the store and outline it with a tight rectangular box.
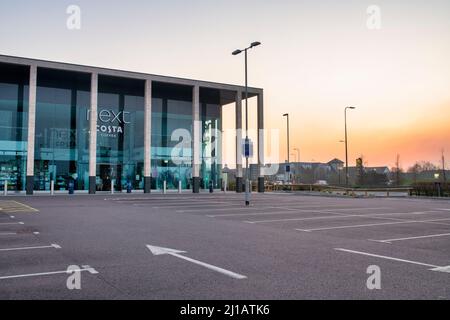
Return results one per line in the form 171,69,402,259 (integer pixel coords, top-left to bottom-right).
0,55,263,103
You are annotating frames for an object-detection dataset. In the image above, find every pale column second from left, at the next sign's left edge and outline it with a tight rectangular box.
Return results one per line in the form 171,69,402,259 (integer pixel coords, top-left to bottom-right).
89,73,98,194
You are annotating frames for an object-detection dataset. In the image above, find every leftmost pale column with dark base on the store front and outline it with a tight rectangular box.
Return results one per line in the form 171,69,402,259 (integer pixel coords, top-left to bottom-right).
26,65,37,195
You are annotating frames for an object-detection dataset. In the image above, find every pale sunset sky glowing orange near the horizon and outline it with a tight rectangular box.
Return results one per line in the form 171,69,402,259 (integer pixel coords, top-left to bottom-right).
0,0,450,169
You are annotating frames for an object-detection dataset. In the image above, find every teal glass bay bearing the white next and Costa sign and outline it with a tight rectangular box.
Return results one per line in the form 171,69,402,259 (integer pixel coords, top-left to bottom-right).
96,76,145,191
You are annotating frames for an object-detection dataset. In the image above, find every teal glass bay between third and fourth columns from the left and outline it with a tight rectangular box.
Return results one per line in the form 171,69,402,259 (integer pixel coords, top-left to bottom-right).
152,83,192,189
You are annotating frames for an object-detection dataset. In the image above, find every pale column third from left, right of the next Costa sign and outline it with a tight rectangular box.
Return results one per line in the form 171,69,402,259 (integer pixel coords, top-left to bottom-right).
144,79,152,193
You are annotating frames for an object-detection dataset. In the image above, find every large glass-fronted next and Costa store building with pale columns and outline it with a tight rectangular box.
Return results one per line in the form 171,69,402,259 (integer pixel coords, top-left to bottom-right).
0,55,264,195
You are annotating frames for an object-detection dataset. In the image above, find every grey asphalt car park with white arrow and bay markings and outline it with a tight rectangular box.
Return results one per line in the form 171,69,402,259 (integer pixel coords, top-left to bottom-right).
0,192,450,300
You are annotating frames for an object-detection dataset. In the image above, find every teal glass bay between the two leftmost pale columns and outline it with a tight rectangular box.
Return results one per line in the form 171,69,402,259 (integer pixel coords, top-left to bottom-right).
34,68,90,191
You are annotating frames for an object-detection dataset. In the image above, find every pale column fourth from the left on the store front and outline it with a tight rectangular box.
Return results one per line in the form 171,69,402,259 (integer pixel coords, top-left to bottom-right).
192,86,201,193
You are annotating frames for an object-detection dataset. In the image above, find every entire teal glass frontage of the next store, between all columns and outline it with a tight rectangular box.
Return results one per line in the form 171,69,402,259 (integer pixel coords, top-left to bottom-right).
0,63,250,193
